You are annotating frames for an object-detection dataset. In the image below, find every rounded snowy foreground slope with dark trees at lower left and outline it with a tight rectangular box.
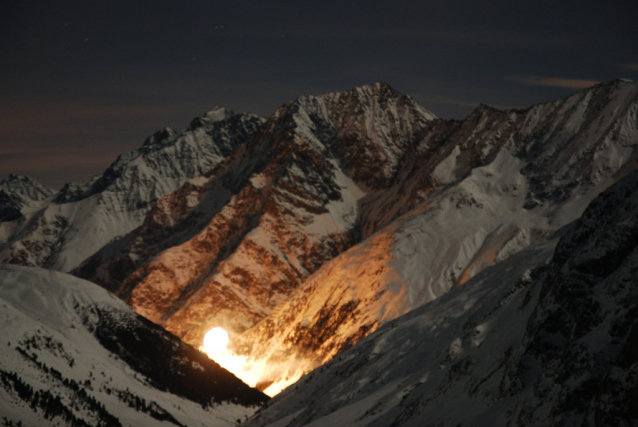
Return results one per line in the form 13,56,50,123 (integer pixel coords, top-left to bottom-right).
0,266,267,427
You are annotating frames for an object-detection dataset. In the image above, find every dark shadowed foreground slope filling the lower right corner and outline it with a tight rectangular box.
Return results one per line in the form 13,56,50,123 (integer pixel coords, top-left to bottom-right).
245,172,638,427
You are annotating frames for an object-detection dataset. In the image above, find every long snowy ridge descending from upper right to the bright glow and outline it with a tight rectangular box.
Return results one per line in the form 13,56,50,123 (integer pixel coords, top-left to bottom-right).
229,78,638,392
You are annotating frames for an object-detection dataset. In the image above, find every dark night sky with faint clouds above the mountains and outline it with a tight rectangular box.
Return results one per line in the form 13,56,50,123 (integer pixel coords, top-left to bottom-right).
0,0,638,189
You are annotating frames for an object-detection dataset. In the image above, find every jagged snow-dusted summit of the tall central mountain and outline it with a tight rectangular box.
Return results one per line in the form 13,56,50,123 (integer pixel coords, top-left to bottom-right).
271,83,436,191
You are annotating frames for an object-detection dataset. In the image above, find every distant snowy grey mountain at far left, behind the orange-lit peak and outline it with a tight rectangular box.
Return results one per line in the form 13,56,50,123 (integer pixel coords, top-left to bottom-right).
0,108,263,271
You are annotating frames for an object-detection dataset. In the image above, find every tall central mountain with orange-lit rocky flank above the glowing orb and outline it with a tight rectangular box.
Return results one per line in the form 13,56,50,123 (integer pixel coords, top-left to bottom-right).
75,84,434,345
